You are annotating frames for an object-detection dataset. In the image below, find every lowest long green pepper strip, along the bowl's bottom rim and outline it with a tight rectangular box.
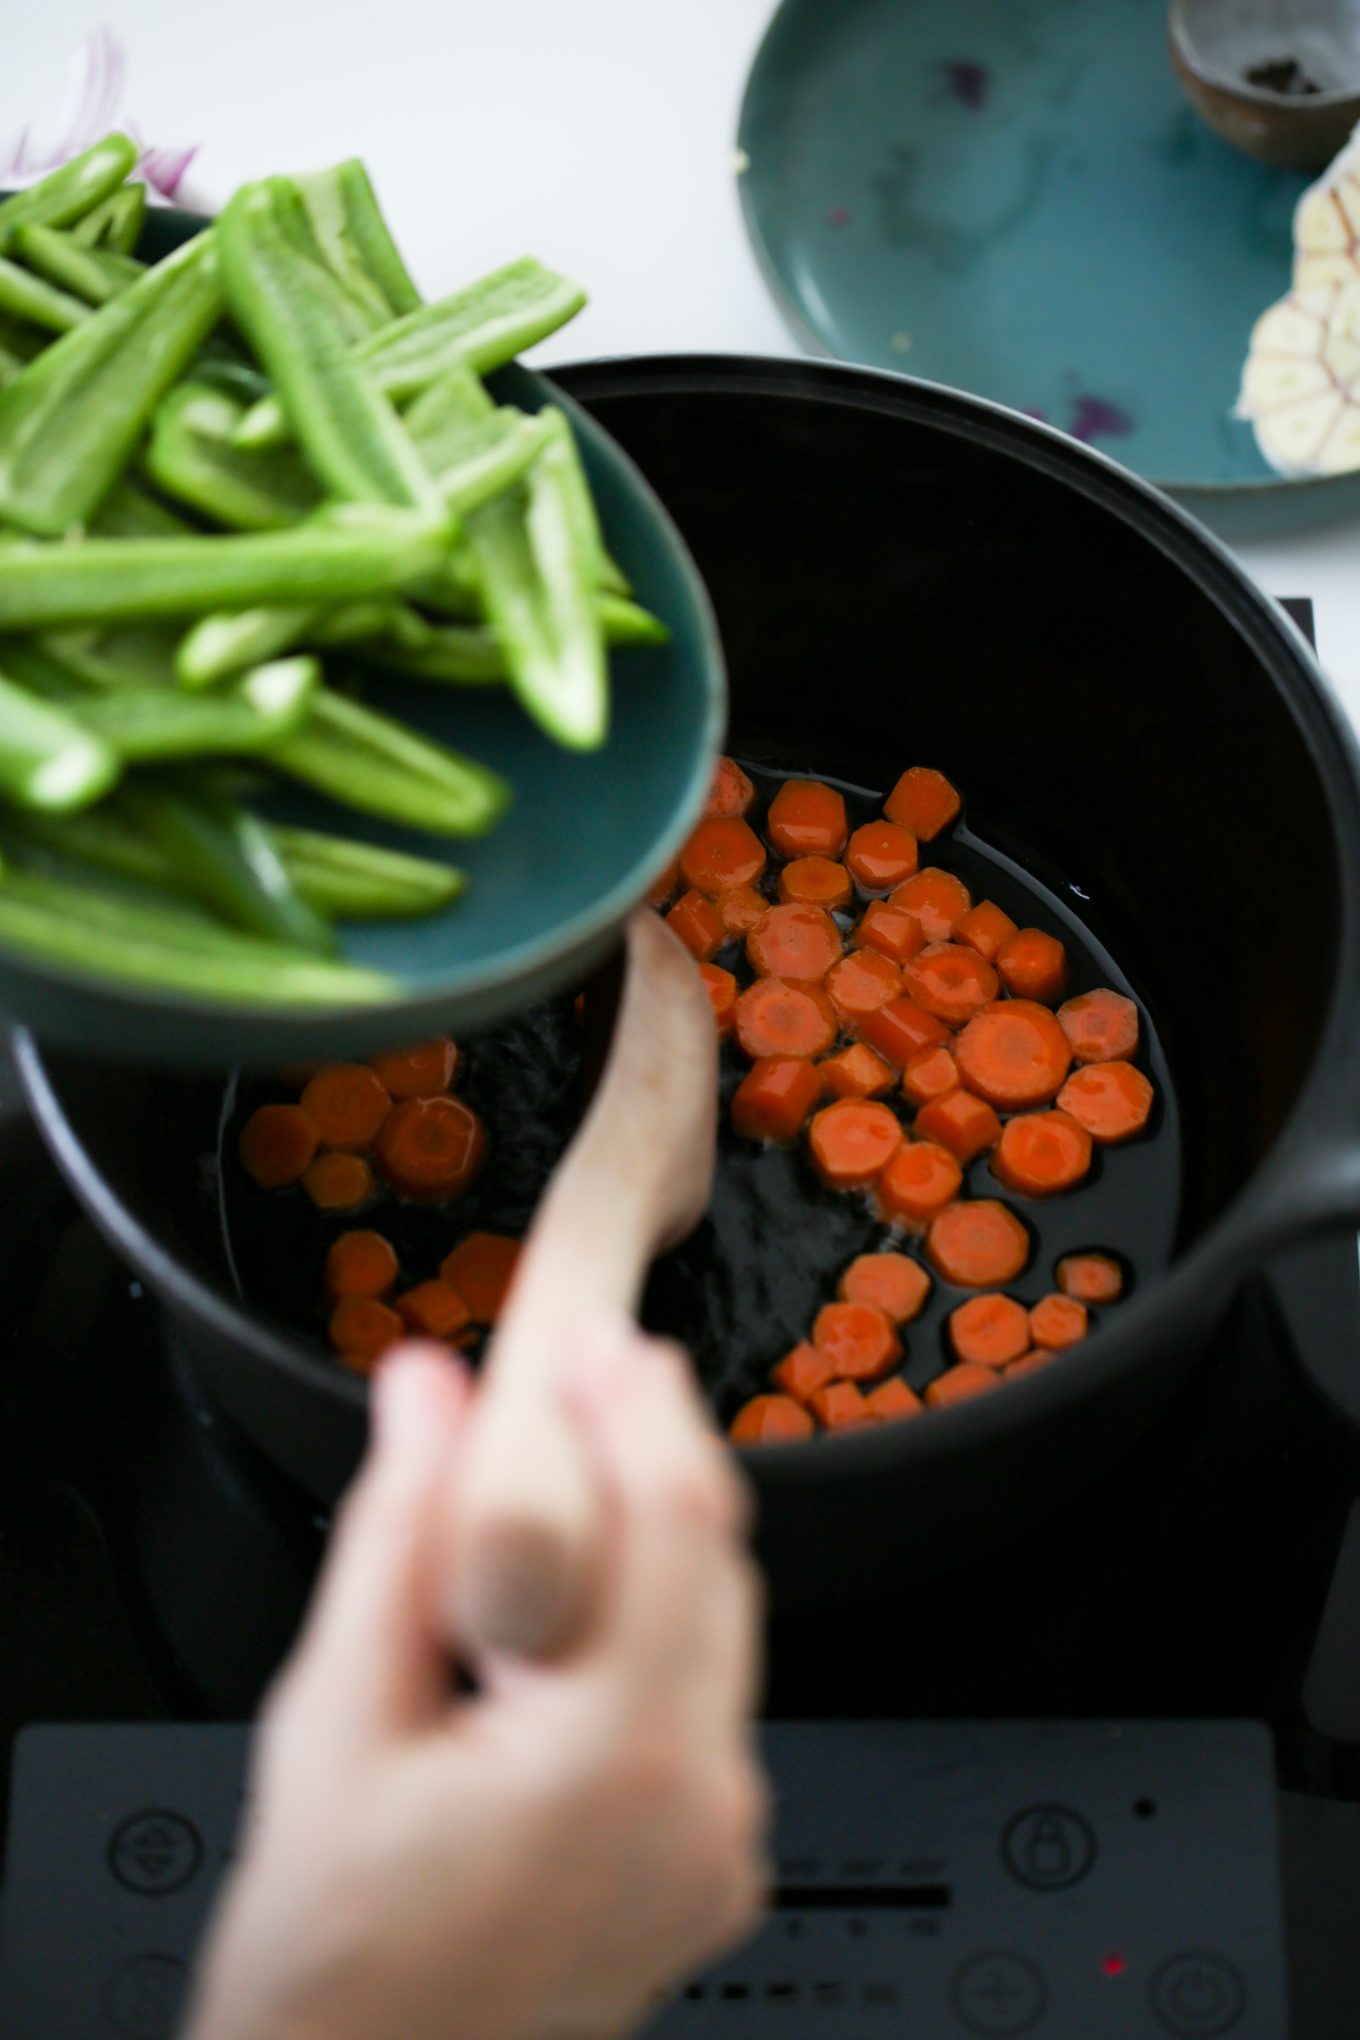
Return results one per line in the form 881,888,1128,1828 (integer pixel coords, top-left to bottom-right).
0,869,400,1008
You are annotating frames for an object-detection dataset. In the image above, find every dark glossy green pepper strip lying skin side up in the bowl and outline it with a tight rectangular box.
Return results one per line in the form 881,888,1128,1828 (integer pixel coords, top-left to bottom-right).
122,779,336,955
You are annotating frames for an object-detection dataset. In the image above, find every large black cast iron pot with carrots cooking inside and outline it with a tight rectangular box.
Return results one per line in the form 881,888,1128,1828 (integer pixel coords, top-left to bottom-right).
18,359,1360,1601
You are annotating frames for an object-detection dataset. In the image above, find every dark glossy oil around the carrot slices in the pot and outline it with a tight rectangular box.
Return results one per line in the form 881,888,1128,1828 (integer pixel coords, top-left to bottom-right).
222,765,1181,1420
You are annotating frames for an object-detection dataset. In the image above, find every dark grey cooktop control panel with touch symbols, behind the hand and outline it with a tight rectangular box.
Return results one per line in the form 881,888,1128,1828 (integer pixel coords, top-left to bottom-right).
0,1722,1289,2040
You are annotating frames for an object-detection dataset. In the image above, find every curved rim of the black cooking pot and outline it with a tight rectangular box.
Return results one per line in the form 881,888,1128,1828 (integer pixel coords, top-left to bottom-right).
14,353,1360,1485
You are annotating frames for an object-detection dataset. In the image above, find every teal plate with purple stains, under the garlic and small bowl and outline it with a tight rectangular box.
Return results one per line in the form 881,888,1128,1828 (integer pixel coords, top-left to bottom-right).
740,0,1360,534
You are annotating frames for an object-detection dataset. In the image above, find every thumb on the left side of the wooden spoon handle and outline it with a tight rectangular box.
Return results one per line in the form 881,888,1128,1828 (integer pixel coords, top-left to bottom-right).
277,1342,469,1754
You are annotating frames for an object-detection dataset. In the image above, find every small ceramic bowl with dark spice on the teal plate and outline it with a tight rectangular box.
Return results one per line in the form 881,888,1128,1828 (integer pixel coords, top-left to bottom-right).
1168,0,1360,169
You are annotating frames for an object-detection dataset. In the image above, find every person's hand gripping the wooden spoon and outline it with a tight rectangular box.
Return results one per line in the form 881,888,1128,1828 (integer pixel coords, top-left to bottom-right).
188,1320,765,2040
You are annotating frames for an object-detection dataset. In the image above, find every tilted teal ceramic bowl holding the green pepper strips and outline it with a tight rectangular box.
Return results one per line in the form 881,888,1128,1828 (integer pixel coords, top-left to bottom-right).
0,212,726,1067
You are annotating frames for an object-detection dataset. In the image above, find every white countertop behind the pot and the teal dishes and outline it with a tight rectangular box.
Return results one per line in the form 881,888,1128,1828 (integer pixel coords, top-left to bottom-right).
0,0,1360,724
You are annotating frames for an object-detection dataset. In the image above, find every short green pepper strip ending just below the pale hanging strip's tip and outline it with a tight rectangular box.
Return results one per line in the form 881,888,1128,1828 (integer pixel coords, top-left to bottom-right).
269,687,510,836
